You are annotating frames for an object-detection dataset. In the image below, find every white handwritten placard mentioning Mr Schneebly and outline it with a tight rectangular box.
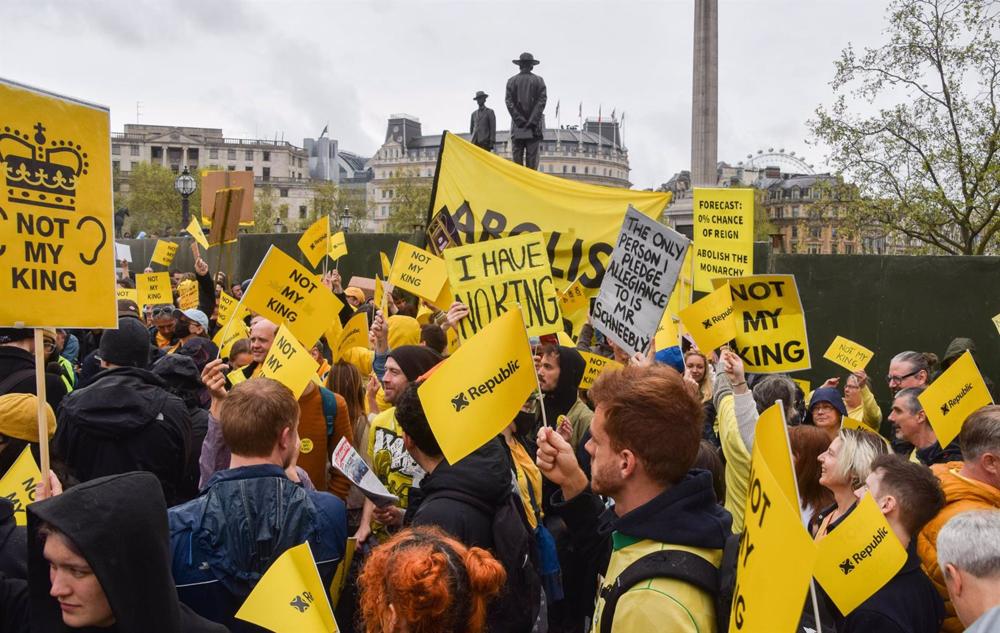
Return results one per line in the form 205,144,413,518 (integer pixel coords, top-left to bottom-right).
591,207,688,355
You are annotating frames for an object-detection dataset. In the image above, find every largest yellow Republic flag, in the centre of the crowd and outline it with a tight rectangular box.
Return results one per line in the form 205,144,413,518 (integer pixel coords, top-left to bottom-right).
418,306,538,464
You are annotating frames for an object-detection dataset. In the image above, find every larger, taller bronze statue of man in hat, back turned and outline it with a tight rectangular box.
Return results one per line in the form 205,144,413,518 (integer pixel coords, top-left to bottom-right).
507,53,546,169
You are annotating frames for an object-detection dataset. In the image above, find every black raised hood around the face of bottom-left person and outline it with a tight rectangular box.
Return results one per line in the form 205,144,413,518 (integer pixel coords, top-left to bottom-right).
28,472,181,633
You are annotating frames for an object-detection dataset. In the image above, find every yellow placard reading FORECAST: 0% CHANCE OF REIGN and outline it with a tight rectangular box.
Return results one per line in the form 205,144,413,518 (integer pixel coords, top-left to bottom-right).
693,187,753,292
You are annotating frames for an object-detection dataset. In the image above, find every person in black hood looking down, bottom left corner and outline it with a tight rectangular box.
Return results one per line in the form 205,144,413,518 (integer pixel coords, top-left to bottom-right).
28,472,227,633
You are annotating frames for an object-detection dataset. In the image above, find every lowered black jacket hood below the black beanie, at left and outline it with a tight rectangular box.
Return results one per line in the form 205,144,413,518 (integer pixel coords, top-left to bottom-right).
60,367,174,439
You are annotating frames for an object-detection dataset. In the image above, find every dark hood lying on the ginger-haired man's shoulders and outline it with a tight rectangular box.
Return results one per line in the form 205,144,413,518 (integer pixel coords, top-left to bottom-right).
614,470,733,549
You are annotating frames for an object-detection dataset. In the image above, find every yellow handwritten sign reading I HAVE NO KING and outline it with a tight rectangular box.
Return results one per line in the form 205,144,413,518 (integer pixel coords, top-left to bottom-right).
444,232,562,341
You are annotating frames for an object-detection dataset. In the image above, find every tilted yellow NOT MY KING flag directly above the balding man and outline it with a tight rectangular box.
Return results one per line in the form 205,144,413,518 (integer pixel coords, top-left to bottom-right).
242,245,343,346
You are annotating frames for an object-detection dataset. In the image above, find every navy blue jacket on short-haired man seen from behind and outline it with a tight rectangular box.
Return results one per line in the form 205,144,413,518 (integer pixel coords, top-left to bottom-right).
168,464,347,633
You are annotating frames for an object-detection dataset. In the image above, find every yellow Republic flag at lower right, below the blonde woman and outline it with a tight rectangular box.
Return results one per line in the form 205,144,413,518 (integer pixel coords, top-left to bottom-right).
813,494,906,615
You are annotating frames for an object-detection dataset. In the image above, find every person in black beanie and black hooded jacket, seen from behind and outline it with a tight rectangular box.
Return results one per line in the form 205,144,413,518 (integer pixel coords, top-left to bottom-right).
52,317,191,505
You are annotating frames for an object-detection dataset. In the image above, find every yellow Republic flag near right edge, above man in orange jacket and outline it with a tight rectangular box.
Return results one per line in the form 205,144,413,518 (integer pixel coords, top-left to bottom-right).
917,352,993,446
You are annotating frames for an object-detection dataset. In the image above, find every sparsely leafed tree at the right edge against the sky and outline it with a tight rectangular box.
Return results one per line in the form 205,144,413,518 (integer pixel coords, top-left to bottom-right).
810,0,1000,255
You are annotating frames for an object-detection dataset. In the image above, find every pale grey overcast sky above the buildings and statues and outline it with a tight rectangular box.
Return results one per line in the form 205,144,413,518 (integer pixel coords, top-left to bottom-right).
0,0,886,188
